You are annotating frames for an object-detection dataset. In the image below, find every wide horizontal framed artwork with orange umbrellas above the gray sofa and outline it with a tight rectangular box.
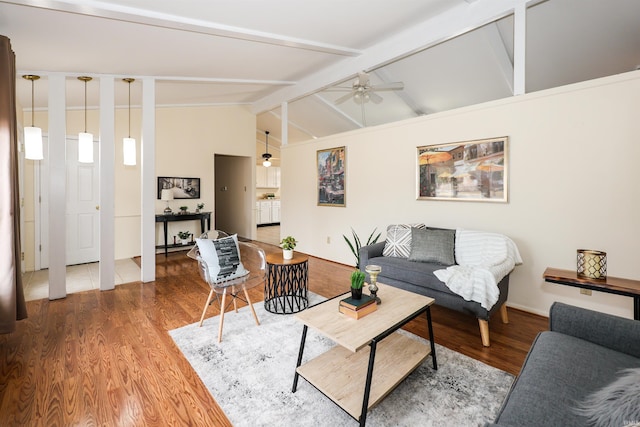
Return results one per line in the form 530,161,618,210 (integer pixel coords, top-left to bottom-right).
416,136,509,203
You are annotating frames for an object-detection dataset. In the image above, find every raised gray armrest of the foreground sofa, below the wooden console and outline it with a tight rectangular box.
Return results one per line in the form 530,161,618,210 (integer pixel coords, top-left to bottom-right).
549,302,640,357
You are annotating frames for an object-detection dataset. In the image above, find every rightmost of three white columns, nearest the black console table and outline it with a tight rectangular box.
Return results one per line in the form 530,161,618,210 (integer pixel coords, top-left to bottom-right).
140,77,156,283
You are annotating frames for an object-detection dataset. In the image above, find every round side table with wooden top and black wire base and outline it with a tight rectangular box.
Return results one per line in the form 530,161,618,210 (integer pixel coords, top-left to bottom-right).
264,251,309,314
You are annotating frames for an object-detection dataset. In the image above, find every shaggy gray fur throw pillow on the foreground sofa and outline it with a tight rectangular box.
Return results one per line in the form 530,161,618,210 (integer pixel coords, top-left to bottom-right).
576,368,640,426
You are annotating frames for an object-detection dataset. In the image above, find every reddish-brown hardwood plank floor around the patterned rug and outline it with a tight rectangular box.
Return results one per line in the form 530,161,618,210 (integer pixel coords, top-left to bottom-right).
0,244,547,427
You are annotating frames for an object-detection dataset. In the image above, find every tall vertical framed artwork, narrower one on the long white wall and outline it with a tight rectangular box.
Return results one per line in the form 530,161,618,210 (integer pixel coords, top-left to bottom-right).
317,147,346,206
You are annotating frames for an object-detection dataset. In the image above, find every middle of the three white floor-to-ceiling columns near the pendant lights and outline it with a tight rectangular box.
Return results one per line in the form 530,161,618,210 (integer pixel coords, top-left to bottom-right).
98,77,116,291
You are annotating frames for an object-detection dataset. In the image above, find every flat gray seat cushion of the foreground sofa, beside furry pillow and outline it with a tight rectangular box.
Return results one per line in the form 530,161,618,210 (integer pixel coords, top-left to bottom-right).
495,331,640,427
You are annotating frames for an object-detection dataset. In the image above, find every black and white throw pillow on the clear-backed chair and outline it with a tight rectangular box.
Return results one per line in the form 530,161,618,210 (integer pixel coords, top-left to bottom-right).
196,234,249,283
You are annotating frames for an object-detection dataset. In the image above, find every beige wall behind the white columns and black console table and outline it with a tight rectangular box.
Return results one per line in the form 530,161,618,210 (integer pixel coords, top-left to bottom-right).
23,106,256,271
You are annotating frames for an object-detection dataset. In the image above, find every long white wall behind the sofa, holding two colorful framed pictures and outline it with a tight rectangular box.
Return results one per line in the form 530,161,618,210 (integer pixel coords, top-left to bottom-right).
281,72,640,317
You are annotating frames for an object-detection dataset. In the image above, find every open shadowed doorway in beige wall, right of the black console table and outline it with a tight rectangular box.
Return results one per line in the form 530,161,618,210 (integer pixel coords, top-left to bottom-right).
213,154,255,240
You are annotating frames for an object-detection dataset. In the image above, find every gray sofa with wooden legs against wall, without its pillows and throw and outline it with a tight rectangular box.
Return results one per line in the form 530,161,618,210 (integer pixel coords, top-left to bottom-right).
358,242,509,347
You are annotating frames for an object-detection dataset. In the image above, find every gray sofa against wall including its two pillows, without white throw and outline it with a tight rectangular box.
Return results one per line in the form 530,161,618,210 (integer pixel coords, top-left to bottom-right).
358,224,509,347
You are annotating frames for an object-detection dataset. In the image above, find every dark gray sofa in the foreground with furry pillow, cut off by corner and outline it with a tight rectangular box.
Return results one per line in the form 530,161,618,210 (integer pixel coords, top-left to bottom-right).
487,302,640,427
